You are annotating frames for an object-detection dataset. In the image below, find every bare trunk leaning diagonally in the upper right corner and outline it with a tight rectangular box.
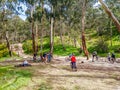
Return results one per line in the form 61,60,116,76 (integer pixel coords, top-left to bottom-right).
98,0,120,32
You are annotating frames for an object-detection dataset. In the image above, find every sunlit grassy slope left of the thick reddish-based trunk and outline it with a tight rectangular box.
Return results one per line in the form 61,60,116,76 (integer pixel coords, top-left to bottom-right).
23,37,80,56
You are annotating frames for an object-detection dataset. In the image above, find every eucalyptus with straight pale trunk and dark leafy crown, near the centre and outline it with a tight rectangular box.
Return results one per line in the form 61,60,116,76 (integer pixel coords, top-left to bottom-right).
47,0,69,53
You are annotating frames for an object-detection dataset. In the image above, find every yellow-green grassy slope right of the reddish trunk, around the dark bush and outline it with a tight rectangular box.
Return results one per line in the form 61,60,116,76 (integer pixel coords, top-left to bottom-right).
86,31,120,57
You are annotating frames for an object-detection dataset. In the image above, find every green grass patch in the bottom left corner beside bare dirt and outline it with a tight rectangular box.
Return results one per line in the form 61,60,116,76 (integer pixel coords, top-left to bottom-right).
0,66,32,90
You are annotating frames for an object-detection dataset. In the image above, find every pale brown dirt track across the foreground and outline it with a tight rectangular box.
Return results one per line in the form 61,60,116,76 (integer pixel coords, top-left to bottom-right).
0,57,120,90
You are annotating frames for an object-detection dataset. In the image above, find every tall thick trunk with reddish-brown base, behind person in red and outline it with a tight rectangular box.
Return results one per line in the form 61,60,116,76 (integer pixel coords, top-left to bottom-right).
82,0,89,60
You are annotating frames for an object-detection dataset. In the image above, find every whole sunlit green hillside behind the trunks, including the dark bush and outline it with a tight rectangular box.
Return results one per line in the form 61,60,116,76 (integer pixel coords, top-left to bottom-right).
23,31,120,57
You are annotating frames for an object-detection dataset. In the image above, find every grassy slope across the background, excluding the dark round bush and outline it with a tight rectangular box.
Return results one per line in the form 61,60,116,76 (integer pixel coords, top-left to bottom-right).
22,30,120,57
